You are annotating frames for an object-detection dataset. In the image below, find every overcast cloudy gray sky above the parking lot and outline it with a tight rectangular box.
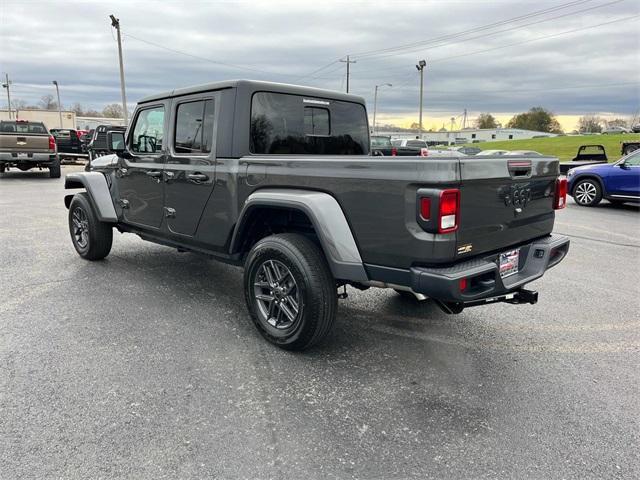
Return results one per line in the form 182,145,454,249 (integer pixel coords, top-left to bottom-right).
0,0,640,129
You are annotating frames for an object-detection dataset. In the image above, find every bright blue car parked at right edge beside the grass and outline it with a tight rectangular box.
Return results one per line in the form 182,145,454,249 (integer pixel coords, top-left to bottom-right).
567,151,640,207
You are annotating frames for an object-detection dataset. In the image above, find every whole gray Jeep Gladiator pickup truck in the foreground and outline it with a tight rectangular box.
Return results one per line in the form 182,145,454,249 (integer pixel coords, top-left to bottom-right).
65,80,569,350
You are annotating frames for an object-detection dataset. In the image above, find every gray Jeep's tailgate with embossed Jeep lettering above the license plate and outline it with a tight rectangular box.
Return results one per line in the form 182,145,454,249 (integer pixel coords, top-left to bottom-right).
457,157,558,258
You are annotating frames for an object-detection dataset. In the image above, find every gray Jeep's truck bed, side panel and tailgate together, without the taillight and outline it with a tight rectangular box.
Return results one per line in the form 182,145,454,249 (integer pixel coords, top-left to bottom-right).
211,155,558,269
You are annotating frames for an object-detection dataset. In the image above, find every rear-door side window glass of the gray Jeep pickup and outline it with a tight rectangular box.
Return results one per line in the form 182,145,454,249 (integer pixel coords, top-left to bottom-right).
173,100,214,154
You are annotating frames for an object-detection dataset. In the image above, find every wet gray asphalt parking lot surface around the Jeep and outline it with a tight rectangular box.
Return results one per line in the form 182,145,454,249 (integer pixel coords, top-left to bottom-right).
0,167,640,479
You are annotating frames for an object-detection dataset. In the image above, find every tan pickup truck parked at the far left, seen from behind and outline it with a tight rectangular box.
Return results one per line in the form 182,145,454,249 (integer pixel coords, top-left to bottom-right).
0,120,60,178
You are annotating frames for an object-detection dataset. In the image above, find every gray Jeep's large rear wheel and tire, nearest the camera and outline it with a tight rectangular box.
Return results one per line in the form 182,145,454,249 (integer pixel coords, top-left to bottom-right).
244,233,338,350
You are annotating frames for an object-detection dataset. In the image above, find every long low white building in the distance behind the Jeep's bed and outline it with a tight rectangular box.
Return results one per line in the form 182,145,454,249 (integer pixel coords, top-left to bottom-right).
376,128,557,145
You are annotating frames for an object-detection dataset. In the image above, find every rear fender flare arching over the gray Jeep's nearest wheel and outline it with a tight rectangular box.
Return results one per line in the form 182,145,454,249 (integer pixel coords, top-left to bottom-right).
230,189,369,282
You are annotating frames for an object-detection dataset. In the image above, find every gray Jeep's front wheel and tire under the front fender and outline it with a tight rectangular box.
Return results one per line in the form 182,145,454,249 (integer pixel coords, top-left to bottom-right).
69,193,113,260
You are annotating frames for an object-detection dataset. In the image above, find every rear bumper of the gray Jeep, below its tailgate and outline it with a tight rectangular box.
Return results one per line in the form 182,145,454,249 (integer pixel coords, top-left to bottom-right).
410,235,569,304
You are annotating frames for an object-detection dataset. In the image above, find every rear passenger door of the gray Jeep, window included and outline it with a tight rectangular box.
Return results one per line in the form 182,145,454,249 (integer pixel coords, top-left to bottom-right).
164,94,217,236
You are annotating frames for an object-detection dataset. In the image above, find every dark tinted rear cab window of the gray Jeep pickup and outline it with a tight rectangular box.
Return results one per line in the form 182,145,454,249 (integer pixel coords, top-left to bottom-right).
250,92,369,155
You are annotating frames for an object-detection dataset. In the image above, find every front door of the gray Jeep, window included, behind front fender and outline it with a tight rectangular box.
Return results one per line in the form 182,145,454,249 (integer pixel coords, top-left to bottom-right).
117,104,166,228
